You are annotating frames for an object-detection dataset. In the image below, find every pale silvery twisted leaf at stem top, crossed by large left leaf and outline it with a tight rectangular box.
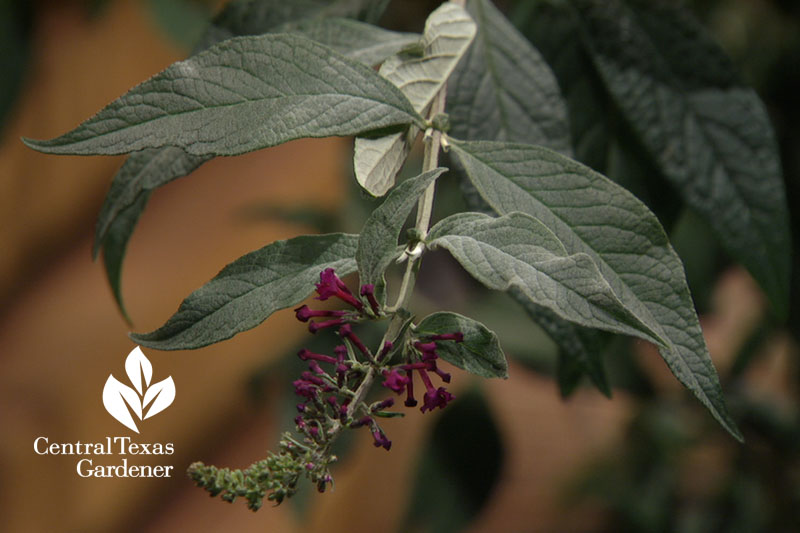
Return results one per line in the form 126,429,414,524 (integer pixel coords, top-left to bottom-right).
353,2,475,196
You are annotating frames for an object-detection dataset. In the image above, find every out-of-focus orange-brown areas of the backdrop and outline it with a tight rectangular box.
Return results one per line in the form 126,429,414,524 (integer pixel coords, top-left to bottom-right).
0,0,797,532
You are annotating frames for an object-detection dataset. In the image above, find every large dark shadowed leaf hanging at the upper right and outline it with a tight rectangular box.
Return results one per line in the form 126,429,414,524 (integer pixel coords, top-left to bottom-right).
574,0,790,316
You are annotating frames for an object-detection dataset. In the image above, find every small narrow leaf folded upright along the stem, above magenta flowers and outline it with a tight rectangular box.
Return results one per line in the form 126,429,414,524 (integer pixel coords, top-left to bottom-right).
356,168,447,302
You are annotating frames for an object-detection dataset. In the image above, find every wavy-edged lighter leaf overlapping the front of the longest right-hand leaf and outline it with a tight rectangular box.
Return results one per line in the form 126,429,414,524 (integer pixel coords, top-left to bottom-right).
428,212,667,345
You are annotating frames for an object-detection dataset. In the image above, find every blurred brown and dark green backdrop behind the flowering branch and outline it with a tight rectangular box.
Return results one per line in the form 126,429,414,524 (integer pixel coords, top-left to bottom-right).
0,0,800,532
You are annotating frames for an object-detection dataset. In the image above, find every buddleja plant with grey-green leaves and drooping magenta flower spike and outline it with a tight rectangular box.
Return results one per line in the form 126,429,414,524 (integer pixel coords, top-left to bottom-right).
25,0,788,509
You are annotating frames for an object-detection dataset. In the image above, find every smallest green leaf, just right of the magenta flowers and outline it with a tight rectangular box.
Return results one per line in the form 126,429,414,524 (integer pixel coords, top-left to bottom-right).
415,312,508,378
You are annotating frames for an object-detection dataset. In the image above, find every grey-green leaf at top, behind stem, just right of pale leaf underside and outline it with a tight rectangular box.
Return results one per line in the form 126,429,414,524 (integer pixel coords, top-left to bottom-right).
447,0,572,155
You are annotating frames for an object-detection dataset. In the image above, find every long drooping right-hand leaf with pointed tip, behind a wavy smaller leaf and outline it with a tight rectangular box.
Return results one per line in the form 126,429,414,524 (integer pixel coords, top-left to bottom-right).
452,138,741,439
